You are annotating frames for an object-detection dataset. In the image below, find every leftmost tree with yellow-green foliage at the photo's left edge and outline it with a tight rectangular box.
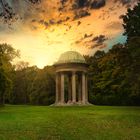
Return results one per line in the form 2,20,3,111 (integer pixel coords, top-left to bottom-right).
0,44,19,104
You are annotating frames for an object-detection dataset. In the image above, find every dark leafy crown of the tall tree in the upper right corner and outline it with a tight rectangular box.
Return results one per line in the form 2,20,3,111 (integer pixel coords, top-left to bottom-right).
122,2,140,39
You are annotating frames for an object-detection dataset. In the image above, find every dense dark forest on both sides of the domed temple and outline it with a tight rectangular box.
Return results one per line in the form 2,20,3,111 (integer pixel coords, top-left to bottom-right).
0,3,140,105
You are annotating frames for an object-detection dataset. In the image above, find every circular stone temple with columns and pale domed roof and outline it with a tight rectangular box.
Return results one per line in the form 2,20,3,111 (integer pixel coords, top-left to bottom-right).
54,51,89,105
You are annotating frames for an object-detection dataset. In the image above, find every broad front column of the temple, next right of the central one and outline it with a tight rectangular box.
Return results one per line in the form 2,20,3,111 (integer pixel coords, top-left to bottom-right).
82,72,86,104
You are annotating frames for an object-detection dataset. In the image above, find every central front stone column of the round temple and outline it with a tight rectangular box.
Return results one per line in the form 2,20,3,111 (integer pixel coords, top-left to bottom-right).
72,72,76,103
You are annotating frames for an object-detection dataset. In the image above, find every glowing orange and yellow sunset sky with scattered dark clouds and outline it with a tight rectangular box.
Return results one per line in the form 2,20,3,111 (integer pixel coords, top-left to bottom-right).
0,0,137,68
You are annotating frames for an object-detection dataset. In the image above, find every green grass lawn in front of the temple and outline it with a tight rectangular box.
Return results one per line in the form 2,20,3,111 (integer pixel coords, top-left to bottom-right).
0,105,140,140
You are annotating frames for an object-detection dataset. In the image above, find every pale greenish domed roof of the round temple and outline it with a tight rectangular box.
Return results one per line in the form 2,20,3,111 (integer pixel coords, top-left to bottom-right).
56,51,86,64
